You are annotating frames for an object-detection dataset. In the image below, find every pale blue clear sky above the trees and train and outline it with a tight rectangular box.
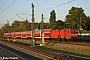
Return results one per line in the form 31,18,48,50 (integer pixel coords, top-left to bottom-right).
0,0,90,27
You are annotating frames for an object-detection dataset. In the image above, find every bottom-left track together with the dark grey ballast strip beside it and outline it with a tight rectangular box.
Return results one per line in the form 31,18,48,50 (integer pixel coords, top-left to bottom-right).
0,41,41,60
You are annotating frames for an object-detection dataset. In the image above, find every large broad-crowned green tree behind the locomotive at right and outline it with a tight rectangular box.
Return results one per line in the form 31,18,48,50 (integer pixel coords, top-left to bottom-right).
65,7,87,29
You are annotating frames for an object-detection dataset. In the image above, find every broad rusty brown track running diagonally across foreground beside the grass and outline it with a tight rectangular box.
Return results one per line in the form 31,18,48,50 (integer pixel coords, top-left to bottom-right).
0,41,89,60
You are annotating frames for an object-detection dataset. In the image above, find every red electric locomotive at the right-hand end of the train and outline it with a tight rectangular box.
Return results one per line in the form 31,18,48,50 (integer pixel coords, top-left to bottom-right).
59,29,78,41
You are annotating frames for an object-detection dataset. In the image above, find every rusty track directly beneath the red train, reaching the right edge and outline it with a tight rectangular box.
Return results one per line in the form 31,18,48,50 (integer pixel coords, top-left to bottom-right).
3,39,90,46
